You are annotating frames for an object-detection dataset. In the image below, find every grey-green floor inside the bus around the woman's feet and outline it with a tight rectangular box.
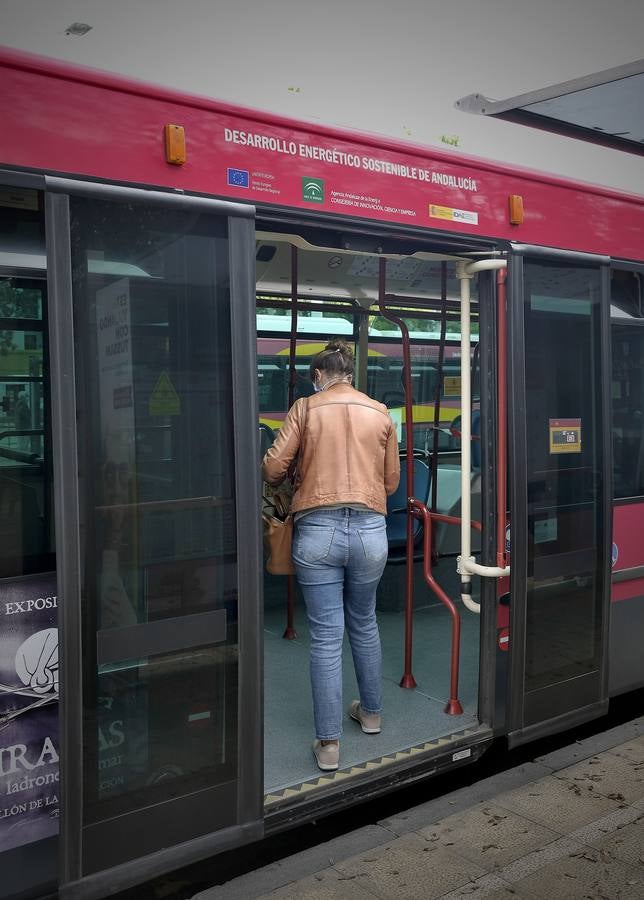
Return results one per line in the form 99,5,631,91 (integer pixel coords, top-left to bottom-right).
264,605,480,793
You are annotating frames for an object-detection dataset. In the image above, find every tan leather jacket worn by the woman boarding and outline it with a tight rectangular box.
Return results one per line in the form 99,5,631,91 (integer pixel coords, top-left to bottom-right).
262,383,400,514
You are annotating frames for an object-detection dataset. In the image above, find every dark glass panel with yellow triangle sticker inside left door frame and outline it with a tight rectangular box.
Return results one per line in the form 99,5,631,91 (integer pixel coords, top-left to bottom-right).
71,198,239,871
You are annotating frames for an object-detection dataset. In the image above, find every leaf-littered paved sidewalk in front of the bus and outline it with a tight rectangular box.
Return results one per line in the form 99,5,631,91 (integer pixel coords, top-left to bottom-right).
193,717,644,900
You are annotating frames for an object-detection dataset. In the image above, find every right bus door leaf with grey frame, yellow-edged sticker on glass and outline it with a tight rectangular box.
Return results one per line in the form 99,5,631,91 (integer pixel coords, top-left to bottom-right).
507,247,612,746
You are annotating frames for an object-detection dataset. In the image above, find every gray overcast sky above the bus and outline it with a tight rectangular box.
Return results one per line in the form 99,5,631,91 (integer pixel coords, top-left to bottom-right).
0,0,644,194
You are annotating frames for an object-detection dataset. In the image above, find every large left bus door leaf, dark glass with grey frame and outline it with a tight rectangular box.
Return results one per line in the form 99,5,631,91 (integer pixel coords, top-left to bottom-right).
46,178,263,898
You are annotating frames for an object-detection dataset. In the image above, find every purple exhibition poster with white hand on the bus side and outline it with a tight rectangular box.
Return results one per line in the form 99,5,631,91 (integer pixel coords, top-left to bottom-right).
0,573,59,852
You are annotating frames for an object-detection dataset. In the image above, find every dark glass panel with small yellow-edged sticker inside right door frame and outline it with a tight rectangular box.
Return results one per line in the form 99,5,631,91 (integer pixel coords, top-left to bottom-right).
524,262,606,725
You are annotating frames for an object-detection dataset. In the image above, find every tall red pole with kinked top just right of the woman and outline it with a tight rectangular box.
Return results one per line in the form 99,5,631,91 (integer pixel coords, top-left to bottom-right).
378,256,416,688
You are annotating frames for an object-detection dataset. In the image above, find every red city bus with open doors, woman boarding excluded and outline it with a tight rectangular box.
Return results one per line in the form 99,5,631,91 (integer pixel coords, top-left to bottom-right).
0,50,644,898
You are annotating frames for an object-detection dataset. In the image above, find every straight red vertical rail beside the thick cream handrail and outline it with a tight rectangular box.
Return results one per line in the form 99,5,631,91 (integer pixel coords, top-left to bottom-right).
496,269,508,568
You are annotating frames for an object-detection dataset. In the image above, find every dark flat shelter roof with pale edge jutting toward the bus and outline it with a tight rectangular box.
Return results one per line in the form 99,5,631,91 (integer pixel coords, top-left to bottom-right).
455,59,644,155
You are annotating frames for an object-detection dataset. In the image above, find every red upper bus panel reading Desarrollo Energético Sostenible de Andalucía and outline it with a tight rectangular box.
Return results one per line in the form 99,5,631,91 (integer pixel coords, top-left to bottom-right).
0,48,644,259
